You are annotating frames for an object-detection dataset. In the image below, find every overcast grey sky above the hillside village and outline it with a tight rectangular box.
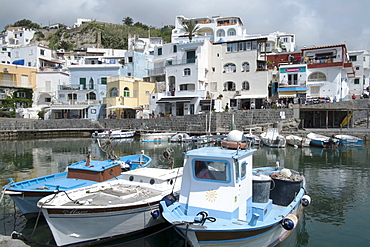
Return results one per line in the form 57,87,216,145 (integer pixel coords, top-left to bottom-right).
0,0,370,51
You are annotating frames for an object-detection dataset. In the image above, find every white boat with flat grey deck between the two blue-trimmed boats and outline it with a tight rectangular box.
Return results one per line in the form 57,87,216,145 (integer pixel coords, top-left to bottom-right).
37,167,183,246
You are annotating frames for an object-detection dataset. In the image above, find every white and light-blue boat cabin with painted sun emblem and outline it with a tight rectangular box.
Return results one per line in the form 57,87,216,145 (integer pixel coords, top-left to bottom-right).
179,147,256,221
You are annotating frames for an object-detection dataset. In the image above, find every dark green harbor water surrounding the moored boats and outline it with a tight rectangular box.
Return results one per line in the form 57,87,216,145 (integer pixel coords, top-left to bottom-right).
0,137,370,247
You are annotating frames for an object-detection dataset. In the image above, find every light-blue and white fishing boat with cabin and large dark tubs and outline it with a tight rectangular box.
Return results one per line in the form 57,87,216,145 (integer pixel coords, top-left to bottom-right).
160,147,311,247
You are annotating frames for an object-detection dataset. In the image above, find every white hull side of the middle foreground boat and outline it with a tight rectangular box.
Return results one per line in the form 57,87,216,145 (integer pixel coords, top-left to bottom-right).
42,205,164,246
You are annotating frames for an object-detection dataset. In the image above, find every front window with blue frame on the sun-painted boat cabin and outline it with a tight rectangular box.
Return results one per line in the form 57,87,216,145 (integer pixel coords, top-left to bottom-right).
193,160,229,182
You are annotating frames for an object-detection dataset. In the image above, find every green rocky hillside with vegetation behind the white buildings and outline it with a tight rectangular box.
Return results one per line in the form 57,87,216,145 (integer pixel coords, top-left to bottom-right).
5,17,173,51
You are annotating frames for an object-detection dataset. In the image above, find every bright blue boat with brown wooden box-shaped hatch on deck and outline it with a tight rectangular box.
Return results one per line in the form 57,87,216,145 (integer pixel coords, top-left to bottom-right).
3,154,152,219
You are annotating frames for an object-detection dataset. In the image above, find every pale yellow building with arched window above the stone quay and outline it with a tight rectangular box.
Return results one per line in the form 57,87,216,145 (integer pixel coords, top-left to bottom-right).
103,77,155,118
